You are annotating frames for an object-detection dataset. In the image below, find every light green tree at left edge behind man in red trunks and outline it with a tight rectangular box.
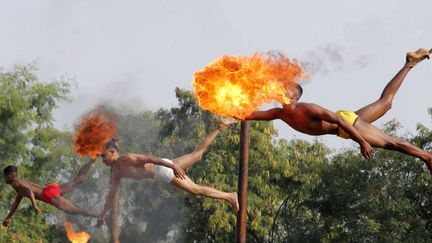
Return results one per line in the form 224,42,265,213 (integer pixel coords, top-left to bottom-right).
0,65,71,242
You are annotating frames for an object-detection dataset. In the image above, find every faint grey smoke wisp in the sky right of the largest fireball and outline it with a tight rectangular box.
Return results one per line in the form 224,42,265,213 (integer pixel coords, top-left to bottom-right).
300,43,372,76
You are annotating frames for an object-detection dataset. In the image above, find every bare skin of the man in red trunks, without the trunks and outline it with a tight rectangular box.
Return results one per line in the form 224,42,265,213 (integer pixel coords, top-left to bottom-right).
3,160,97,226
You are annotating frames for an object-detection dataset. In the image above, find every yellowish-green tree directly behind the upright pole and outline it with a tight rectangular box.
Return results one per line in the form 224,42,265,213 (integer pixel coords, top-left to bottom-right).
158,90,329,242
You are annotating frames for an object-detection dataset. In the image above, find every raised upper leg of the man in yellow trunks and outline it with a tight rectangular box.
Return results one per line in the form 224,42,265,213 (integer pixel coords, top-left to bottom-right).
355,49,429,123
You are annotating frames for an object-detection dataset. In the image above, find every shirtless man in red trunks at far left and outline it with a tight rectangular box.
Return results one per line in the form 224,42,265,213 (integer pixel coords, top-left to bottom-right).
3,160,98,226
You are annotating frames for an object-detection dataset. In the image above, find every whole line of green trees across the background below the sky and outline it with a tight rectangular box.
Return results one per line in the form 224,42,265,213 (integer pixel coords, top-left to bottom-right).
0,65,432,242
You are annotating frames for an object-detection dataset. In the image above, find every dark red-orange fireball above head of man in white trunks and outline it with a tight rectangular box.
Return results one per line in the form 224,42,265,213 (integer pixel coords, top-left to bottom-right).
74,112,117,159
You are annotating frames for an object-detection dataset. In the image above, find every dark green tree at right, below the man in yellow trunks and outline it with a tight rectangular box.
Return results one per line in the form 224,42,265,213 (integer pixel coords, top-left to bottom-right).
279,117,432,242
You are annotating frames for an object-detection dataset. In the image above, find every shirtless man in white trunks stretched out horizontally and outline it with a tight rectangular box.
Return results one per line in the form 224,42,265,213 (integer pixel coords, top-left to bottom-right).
97,120,239,228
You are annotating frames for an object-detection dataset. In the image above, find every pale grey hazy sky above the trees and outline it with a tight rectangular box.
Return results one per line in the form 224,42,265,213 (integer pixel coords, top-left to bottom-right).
0,0,432,148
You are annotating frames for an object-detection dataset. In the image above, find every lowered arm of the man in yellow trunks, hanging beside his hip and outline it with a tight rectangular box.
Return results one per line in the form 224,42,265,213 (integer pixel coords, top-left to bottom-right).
314,106,372,158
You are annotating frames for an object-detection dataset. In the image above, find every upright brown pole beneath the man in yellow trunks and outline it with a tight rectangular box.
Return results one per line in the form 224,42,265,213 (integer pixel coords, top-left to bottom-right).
236,121,249,243
